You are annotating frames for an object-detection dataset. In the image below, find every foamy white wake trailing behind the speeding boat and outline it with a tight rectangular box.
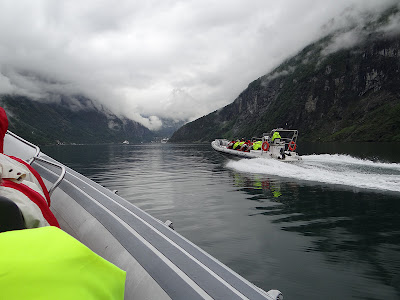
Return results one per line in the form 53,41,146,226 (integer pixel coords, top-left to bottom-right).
227,154,400,192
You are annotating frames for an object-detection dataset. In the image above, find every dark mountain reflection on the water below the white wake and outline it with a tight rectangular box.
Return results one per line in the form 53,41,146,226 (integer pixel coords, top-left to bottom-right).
228,169,400,298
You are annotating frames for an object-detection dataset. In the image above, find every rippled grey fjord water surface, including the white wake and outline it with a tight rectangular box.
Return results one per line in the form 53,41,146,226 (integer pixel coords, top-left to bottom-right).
42,143,400,299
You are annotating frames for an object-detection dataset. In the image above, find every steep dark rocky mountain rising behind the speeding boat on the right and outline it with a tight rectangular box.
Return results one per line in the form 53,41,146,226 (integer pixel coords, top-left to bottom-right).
170,8,400,142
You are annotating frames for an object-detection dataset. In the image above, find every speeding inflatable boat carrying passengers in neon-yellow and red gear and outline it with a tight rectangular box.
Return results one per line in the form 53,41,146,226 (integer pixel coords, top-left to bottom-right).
211,128,301,161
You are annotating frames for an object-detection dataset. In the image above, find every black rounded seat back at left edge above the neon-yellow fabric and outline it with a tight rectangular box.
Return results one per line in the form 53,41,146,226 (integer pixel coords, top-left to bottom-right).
0,196,26,232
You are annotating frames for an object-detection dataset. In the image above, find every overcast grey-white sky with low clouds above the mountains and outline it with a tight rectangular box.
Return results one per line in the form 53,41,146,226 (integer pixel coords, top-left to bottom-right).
0,0,399,129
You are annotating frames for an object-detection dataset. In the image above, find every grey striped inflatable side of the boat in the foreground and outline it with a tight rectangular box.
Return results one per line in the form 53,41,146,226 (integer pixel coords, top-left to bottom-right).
4,131,283,300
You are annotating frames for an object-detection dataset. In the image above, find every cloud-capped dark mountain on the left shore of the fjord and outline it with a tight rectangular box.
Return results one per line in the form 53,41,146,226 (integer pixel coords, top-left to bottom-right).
0,95,154,145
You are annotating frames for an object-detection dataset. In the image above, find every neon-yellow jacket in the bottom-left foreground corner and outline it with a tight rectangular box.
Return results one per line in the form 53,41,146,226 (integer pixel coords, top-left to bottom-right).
0,226,126,300
